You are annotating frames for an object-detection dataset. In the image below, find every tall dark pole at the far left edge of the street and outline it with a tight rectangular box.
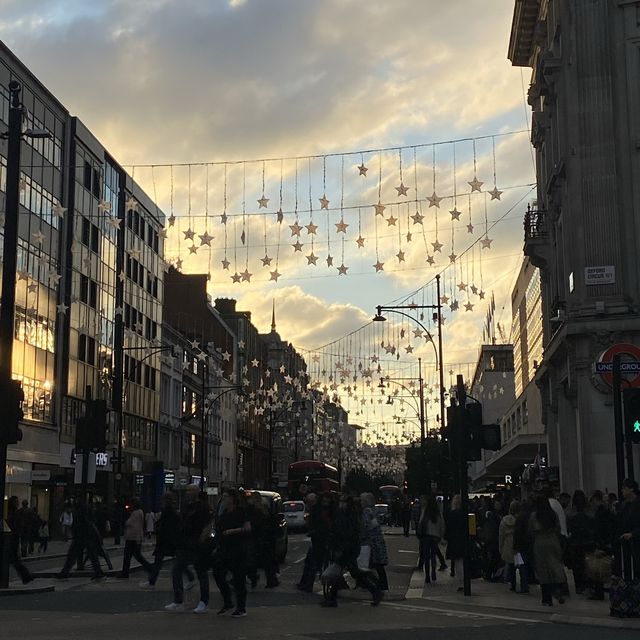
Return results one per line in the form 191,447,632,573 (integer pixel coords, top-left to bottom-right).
0,80,23,588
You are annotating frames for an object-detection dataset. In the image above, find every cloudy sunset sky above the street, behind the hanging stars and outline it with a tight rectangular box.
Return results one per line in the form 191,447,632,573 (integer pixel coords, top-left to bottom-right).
0,0,535,440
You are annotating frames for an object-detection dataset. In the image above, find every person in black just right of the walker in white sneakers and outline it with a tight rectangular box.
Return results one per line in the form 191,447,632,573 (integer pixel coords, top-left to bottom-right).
213,489,251,618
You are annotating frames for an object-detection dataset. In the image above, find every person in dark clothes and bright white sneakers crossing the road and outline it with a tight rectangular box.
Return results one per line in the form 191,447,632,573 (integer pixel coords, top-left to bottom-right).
165,485,211,614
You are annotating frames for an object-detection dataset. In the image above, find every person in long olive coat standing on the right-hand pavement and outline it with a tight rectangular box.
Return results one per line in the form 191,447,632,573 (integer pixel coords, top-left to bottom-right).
529,494,567,607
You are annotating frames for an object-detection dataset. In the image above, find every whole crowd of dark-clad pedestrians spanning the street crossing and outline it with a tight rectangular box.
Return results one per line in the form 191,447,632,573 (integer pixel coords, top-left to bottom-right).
7,480,640,617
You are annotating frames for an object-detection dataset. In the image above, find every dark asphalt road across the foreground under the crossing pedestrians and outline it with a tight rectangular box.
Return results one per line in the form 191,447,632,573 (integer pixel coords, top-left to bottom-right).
0,534,637,640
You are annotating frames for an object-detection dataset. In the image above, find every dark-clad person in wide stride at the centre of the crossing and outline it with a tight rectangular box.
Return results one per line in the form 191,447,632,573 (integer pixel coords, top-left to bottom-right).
320,495,382,607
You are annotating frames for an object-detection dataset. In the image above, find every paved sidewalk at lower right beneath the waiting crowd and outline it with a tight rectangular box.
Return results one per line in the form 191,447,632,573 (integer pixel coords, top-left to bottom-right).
407,570,640,630
